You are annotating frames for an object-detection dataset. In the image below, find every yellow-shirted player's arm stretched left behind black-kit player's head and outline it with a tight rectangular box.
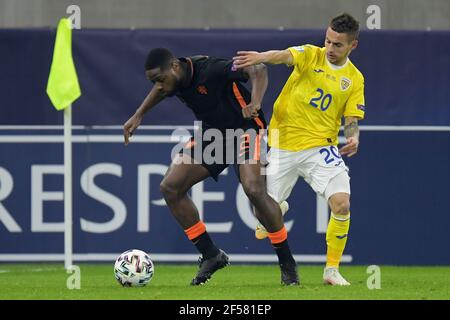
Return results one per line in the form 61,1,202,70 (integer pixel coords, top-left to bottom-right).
233,49,294,69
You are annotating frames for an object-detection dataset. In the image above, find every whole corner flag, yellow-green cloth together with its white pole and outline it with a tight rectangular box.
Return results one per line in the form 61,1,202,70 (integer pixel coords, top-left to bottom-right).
47,18,81,269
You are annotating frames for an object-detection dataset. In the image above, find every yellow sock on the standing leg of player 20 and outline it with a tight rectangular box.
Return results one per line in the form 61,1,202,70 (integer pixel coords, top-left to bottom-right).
326,212,350,268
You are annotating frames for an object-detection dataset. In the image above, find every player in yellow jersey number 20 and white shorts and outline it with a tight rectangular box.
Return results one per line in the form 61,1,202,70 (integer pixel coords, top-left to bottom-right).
233,13,365,285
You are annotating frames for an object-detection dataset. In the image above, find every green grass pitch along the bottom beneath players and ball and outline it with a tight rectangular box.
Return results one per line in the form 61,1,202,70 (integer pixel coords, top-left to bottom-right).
0,263,450,300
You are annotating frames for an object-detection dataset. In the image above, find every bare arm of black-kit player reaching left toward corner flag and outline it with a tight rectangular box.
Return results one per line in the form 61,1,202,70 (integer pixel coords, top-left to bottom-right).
123,84,165,145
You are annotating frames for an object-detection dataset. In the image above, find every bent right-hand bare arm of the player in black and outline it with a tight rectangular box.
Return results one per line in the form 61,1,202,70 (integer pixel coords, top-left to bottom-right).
242,63,269,119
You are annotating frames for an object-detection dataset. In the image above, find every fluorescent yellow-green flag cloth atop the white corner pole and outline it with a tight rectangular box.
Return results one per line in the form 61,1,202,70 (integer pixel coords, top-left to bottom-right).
47,18,81,110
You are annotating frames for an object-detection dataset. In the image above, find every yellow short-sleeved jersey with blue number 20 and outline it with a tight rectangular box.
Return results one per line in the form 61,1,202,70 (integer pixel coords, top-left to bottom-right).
269,45,365,151
